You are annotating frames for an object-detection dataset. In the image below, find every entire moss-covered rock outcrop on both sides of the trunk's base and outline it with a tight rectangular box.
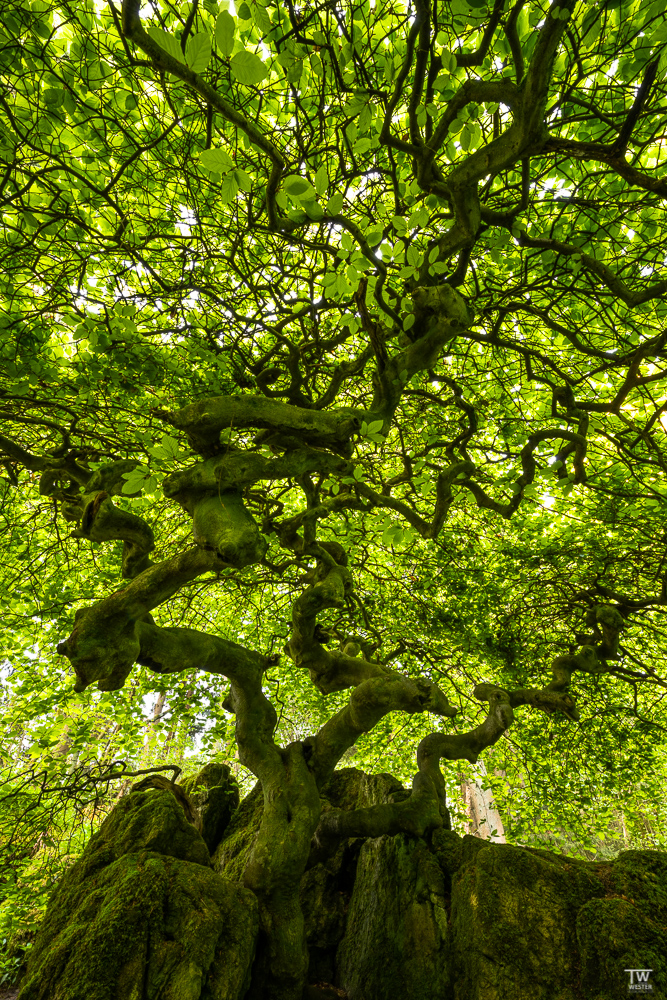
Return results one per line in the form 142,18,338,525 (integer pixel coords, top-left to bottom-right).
20,765,667,1000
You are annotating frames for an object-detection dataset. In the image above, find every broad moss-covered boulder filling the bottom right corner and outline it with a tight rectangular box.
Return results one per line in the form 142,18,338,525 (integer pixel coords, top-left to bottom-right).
438,833,667,1000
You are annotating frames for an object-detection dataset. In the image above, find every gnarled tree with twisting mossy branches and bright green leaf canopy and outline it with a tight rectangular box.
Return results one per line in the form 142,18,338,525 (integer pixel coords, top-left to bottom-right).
0,0,667,998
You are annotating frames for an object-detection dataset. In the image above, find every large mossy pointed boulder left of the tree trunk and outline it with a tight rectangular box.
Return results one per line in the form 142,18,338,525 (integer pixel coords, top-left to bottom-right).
20,789,258,1000
